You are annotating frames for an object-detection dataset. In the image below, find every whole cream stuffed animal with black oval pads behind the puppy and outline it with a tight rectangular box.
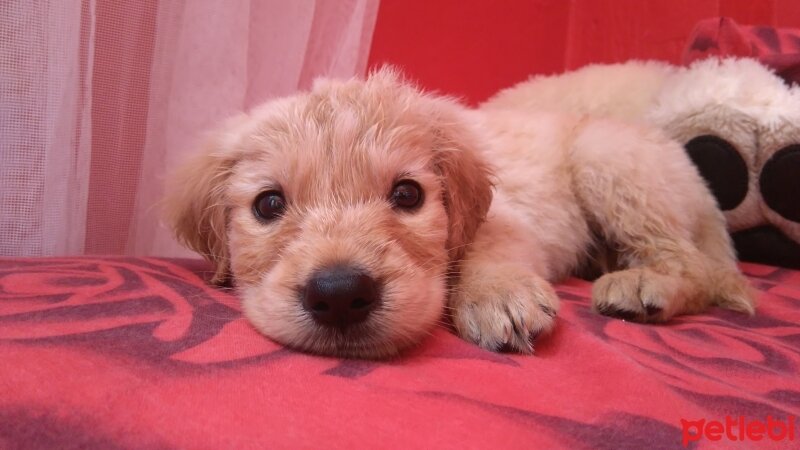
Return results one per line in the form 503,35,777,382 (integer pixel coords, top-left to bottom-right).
481,58,800,268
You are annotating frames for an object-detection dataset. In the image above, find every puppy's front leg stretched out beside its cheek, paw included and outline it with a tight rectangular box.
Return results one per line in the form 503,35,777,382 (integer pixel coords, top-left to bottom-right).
449,205,558,353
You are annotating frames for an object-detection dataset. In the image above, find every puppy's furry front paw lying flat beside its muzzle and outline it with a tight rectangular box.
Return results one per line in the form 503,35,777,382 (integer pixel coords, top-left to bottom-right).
450,266,558,353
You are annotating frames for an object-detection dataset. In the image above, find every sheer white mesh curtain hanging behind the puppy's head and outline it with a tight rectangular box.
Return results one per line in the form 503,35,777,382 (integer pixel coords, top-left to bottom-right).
0,0,378,256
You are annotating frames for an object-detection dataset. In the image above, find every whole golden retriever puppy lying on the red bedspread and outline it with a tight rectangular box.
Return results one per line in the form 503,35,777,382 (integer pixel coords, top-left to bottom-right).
166,69,753,358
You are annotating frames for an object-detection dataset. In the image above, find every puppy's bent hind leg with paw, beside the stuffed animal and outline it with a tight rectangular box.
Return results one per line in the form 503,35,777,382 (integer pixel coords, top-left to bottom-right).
570,121,752,321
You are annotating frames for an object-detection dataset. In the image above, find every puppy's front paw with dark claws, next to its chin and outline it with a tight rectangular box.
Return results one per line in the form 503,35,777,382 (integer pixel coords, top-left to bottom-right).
452,280,558,354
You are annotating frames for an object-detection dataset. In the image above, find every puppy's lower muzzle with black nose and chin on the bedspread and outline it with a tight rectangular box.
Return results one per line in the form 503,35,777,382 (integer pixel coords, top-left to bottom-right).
243,258,445,359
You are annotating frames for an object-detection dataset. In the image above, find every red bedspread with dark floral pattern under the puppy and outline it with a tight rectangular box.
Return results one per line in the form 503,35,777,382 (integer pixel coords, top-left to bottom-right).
0,257,800,449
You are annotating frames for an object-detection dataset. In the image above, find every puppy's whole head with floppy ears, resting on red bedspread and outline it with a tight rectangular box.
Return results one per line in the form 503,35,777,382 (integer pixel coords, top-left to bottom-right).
166,69,492,357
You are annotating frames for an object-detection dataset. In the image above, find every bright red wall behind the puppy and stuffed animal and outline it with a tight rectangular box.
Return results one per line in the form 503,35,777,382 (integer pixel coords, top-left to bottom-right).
369,0,800,103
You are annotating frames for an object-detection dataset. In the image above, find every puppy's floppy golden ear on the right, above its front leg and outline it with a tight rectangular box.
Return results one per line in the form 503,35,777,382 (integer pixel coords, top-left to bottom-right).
432,98,493,261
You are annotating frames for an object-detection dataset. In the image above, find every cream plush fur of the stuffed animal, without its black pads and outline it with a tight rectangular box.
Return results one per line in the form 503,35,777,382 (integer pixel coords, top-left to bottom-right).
482,58,800,242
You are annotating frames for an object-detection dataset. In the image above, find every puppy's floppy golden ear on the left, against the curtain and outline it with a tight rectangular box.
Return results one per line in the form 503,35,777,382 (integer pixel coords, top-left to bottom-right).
163,114,247,284
